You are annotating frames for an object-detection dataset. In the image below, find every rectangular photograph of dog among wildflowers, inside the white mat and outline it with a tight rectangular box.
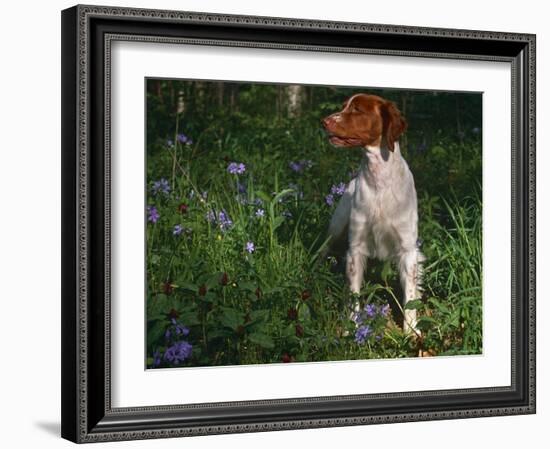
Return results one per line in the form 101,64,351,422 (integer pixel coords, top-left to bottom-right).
143,78,483,369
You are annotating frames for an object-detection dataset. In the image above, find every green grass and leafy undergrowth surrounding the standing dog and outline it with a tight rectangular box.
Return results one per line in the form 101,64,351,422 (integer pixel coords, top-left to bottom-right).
146,108,482,367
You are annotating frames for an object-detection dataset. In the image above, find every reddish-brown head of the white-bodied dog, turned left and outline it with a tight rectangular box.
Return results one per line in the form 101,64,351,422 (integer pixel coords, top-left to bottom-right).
321,94,407,151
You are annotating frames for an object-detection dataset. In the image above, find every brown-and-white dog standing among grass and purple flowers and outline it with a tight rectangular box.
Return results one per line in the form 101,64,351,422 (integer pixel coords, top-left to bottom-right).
322,94,424,332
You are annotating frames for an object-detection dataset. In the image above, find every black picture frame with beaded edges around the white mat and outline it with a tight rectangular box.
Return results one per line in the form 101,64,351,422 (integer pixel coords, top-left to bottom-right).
61,5,535,443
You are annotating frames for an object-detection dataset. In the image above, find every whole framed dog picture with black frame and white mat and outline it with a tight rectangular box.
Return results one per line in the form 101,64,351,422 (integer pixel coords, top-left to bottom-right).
62,6,535,442
